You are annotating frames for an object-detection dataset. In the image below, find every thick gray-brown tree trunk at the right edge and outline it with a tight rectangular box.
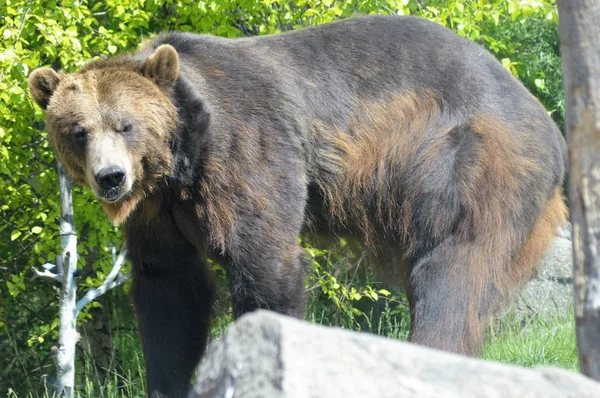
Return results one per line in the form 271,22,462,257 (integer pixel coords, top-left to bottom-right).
558,0,600,380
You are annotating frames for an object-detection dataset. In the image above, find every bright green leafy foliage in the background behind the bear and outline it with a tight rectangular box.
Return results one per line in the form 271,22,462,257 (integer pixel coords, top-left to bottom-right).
0,0,564,395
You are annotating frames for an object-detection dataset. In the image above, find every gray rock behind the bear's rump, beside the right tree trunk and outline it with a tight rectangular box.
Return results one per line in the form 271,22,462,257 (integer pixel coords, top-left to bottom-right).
508,237,573,320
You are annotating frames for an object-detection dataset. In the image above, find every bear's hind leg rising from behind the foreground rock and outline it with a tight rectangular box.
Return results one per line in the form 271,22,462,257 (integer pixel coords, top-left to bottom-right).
410,237,502,355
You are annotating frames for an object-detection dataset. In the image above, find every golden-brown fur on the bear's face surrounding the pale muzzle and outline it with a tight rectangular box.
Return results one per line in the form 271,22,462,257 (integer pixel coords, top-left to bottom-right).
42,64,178,225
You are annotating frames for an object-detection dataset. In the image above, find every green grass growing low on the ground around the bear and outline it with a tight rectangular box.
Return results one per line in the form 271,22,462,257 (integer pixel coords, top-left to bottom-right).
2,305,578,398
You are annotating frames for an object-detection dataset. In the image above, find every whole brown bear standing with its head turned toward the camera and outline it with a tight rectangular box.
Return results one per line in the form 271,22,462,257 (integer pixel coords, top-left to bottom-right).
29,16,566,397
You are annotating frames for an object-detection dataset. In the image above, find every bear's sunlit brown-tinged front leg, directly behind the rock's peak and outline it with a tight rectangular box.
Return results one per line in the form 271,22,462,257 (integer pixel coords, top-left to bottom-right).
211,197,306,318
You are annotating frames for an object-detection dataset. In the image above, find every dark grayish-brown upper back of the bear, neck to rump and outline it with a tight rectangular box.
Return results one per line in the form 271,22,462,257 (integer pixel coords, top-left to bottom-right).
144,16,553,130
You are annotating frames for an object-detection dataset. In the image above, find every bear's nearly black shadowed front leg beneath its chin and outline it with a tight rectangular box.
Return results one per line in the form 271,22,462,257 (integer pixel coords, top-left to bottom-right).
124,204,216,398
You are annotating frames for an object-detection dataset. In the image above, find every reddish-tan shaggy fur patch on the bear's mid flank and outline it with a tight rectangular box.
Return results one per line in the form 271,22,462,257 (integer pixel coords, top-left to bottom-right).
322,93,448,241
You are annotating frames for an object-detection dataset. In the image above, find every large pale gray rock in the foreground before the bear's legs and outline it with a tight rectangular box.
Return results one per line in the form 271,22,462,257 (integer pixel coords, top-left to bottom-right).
189,311,600,398
